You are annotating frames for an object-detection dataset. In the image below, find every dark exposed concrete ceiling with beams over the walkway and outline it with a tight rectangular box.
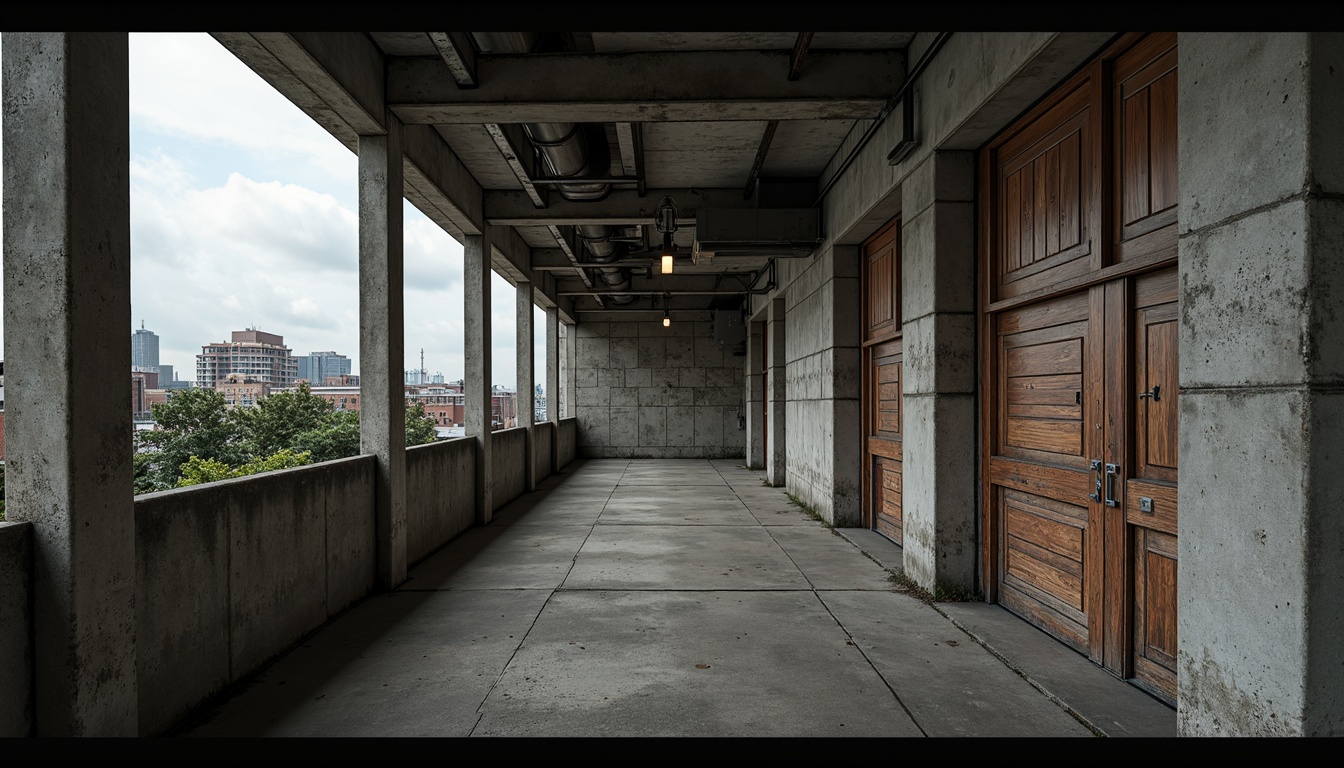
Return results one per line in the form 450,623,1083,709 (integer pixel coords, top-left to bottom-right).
223,32,914,316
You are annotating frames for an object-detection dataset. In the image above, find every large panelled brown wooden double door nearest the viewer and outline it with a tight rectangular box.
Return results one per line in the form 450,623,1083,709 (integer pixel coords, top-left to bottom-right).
981,34,1179,701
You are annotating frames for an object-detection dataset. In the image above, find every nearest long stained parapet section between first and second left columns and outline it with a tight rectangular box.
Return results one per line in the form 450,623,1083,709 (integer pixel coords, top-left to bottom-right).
136,456,374,734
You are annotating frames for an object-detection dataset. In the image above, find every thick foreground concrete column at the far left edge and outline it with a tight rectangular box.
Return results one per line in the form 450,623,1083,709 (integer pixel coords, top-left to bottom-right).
0,32,138,736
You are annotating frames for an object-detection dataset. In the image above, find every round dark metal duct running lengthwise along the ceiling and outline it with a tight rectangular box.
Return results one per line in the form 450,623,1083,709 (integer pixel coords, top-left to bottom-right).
472,32,634,304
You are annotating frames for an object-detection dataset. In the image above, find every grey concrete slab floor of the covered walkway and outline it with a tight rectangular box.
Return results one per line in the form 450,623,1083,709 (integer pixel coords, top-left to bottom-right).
170,460,1176,737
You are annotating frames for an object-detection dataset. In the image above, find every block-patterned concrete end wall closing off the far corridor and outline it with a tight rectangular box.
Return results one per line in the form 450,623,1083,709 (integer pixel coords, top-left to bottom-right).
575,317,746,459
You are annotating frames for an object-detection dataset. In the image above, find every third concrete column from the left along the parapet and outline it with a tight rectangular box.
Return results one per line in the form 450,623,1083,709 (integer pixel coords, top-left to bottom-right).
462,226,495,526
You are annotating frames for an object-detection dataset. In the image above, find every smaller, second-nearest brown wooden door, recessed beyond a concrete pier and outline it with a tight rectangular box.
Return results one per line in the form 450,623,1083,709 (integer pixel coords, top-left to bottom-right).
862,213,903,543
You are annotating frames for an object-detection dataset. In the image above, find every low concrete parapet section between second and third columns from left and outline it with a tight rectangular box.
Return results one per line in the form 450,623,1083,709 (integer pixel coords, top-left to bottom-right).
406,437,476,564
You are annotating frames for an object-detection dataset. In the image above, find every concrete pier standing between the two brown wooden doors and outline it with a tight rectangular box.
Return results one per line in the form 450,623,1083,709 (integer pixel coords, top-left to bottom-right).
900,152,977,590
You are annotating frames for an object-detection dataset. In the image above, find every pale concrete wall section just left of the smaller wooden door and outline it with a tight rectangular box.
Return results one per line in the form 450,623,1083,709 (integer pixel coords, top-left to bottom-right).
785,246,860,526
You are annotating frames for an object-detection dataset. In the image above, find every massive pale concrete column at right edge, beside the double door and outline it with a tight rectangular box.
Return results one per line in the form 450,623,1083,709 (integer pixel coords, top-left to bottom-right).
1176,32,1344,736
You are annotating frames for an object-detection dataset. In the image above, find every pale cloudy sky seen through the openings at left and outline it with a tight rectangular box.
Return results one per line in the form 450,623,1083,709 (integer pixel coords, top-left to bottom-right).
0,34,546,387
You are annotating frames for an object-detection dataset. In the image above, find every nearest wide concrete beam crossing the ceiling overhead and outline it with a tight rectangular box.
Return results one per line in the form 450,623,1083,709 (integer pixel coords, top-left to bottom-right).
387,51,905,124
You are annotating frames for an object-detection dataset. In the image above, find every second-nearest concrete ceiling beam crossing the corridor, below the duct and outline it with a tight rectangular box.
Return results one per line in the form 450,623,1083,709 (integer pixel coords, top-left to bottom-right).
484,188,755,229
